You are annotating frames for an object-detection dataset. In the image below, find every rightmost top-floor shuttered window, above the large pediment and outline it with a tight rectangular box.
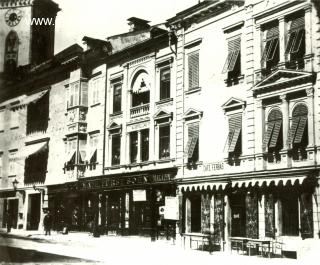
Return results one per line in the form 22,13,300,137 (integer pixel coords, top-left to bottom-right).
285,14,306,69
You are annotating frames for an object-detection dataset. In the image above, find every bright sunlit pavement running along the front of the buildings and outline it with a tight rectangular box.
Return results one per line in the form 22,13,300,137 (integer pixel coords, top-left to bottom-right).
0,229,320,265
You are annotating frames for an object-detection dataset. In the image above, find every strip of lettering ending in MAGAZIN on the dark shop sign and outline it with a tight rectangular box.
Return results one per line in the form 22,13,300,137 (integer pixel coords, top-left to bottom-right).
75,173,174,190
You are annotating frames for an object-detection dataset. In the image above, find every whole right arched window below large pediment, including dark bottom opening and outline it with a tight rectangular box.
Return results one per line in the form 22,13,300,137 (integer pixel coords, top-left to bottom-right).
288,104,308,160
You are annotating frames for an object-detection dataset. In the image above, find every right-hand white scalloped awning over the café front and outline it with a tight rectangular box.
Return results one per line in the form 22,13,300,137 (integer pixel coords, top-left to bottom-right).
231,176,306,188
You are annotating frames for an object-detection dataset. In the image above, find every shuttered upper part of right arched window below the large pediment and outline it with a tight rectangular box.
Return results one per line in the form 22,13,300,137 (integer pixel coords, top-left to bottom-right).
289,104,308,147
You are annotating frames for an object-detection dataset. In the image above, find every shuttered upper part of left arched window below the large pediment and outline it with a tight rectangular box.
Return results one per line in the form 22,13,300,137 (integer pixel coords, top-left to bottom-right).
263,109,283,151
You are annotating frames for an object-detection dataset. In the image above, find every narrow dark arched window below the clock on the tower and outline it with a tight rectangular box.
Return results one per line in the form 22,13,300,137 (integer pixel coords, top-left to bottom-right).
4,31,19,73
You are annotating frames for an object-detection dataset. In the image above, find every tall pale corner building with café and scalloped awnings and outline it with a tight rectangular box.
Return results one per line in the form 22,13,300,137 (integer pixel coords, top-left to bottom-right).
168,1,320,256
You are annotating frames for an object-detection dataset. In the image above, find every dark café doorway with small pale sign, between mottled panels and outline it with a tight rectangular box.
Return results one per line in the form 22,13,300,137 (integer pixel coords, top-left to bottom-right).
230,195,246,237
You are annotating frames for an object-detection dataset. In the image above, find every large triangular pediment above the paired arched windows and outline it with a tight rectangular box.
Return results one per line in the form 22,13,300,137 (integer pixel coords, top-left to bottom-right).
252,69,315,95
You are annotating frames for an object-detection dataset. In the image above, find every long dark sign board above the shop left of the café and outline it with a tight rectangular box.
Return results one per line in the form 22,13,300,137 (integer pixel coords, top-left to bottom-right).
67,169,177,190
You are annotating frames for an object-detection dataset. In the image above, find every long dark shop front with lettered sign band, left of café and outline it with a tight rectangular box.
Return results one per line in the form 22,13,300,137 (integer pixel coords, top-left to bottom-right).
48,168,177,236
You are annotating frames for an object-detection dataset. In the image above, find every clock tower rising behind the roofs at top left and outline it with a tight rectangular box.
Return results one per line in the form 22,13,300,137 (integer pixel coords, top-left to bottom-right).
0,0,60,78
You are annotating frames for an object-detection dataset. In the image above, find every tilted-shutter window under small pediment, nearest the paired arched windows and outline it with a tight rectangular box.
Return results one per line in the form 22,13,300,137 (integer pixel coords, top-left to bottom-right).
228,113,242,166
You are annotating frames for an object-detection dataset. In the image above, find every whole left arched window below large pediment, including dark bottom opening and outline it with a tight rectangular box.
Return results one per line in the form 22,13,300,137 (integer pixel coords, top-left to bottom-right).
263,109,283,162
